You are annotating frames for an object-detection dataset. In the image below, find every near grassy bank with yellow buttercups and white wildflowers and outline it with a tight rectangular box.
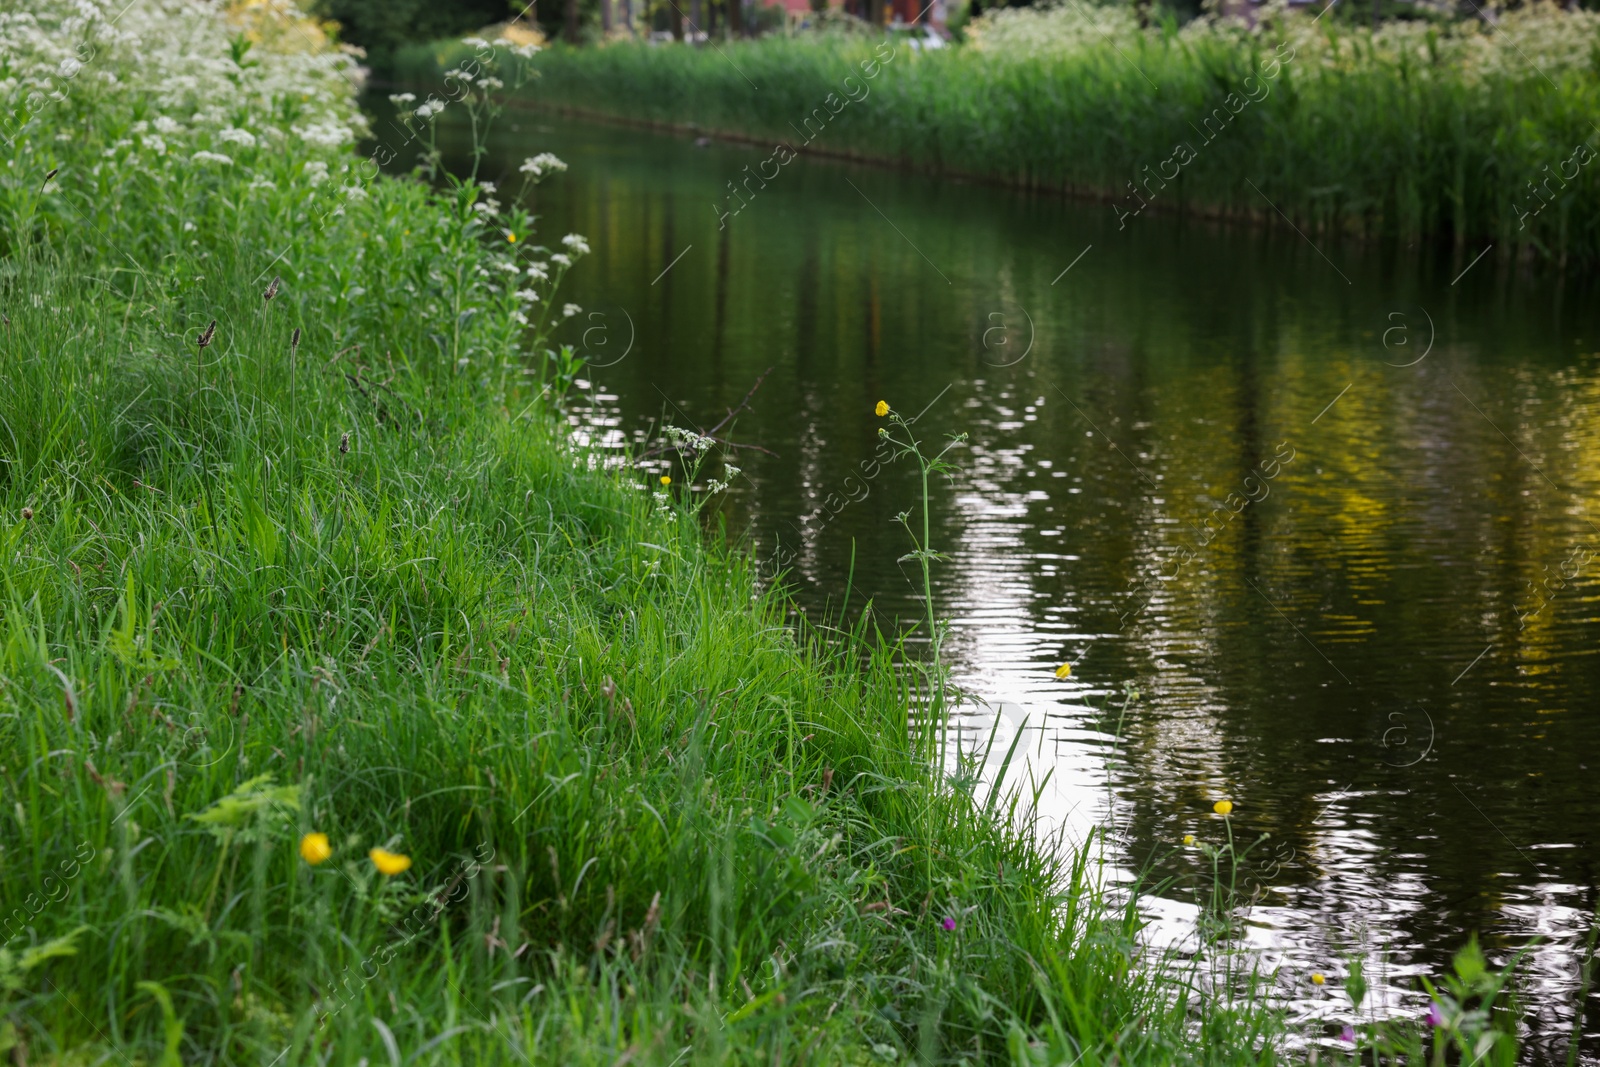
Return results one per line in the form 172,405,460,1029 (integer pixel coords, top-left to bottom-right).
0,0,1318,1067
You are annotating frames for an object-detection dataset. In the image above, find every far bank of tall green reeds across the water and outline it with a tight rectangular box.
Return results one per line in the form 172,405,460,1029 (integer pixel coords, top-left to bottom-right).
406,3,1600,266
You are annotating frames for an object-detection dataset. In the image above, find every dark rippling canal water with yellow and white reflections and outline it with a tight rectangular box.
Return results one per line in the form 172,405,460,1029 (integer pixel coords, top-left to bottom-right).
400,103,1600,1061
